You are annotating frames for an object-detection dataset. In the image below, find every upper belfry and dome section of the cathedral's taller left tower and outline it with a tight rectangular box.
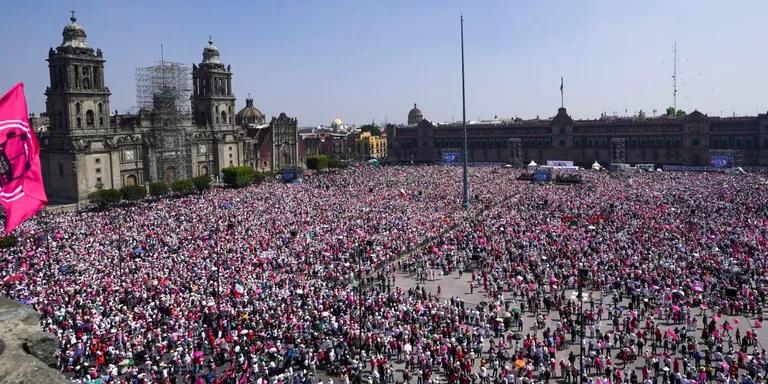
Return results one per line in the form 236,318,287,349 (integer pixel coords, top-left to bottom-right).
45,11,110,135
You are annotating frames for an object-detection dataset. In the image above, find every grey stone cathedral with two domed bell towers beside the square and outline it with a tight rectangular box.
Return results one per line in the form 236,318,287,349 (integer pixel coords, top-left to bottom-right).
40,14,301,203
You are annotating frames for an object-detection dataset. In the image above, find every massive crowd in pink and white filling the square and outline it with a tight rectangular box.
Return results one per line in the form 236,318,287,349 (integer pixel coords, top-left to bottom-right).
0,166,768,384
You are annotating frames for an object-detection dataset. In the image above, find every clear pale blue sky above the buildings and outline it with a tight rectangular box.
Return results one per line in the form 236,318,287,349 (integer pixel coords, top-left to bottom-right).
0,0,768,126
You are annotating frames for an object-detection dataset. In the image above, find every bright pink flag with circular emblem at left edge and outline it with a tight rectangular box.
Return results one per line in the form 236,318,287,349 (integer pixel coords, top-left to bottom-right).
0,83,48,234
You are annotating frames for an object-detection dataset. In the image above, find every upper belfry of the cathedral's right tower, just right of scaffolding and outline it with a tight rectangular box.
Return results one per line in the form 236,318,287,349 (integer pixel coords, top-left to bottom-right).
192,38,235,130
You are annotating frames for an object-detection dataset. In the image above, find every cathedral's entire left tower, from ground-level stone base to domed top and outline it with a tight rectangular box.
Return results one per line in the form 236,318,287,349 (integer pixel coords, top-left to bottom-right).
40,11,112,203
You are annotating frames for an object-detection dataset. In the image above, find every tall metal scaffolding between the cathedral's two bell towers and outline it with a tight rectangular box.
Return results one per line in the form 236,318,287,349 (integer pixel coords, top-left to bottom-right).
136,59,193,181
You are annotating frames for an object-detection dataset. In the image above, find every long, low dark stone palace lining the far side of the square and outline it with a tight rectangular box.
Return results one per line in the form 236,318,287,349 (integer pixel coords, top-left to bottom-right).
386,108,768,166
